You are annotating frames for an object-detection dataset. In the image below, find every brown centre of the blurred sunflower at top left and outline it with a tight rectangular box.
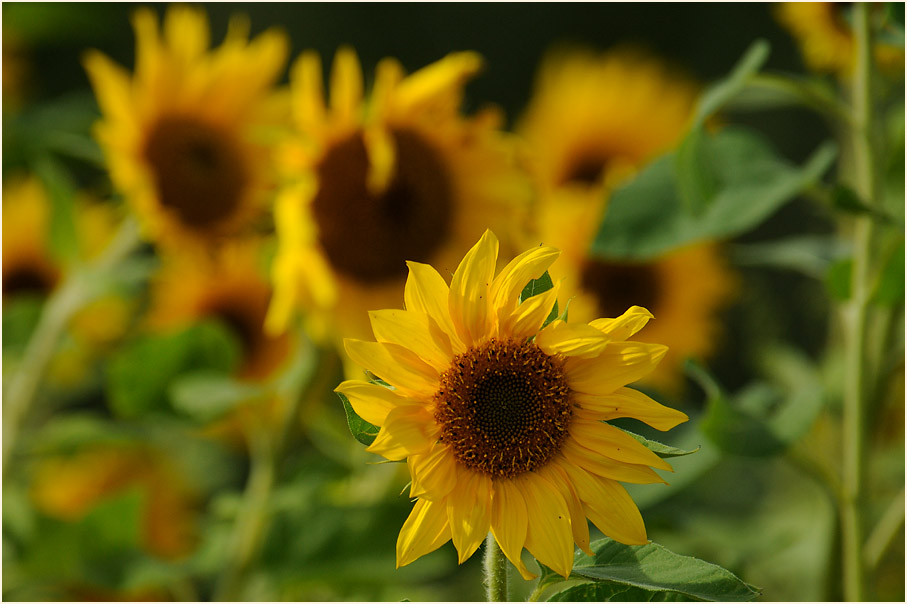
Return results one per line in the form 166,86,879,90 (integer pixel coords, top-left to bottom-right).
144,117,249,230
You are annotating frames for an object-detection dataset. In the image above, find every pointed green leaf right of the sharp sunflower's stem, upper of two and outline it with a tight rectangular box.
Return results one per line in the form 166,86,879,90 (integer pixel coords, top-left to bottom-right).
570,539,759,602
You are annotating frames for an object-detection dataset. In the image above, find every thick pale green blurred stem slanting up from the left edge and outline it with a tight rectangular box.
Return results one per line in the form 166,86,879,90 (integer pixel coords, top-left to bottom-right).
2,219,139,477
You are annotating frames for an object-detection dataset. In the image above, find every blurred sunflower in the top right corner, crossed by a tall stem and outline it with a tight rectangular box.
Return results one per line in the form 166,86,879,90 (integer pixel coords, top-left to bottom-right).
775,2,904,76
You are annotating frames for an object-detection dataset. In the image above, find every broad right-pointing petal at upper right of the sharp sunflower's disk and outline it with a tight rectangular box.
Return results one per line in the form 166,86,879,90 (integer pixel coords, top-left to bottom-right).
567,342,668,395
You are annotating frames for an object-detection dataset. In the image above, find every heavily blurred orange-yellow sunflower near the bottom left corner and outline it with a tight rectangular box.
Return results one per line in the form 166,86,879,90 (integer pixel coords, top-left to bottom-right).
30,444,196,559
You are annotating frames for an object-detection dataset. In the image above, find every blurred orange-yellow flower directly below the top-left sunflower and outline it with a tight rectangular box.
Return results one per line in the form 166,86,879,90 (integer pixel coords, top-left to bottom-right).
148,239,290,379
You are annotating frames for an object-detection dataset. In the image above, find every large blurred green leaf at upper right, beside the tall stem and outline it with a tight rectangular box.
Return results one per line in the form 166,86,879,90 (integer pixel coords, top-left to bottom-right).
592,127,836,260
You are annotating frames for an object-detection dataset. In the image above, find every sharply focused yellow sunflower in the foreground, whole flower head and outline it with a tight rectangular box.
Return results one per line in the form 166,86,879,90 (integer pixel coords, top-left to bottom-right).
337,231,688,579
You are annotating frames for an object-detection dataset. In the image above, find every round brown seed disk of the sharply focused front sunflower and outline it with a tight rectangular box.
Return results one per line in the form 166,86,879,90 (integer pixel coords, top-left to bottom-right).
434,338,572,477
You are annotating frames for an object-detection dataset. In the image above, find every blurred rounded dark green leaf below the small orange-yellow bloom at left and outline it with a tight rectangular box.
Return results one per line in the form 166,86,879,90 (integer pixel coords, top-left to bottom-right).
107,321,240,417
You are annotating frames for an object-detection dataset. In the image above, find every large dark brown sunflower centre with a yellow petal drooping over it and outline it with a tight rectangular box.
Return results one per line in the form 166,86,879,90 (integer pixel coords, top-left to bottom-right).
312,130,453,283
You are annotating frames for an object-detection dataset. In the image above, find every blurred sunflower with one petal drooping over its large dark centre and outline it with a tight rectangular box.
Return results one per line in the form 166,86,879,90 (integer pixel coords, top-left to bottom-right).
268,48,528,358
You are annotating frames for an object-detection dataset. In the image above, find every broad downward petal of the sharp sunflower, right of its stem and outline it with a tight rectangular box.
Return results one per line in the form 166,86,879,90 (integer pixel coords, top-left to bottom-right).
516,474,573,579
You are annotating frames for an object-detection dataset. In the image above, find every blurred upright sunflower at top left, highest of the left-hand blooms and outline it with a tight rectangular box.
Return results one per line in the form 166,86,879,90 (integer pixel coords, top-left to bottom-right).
85,6,288,250
